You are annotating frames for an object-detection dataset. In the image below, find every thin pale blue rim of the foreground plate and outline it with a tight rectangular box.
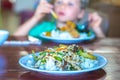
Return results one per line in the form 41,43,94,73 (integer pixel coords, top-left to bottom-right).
19,53,108,74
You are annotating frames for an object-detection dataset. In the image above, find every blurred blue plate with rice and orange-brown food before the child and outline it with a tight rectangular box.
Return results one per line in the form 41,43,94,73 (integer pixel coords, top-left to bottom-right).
40,22,96,43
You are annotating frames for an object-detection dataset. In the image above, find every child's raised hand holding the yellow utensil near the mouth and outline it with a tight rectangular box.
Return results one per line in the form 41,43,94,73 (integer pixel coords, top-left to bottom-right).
33,0,53,20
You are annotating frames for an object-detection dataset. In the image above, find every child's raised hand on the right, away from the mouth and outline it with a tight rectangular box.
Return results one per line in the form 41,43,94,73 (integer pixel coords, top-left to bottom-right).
89,12,102,28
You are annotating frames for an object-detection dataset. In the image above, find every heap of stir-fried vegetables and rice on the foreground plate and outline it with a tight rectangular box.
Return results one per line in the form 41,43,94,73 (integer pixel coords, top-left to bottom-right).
33,44,97,71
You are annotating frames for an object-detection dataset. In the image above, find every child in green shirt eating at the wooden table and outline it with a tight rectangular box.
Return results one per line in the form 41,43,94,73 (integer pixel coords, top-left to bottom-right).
14,0,105,38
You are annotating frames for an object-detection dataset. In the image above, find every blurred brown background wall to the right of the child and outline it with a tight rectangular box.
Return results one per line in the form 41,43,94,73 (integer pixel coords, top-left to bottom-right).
90,0,120,37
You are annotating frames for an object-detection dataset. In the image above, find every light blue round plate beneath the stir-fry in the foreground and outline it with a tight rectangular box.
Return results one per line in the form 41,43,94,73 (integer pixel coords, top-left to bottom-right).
19,53,108,75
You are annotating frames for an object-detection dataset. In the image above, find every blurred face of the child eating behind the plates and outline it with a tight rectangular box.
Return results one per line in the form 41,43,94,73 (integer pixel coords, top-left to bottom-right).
55,0,81,22
